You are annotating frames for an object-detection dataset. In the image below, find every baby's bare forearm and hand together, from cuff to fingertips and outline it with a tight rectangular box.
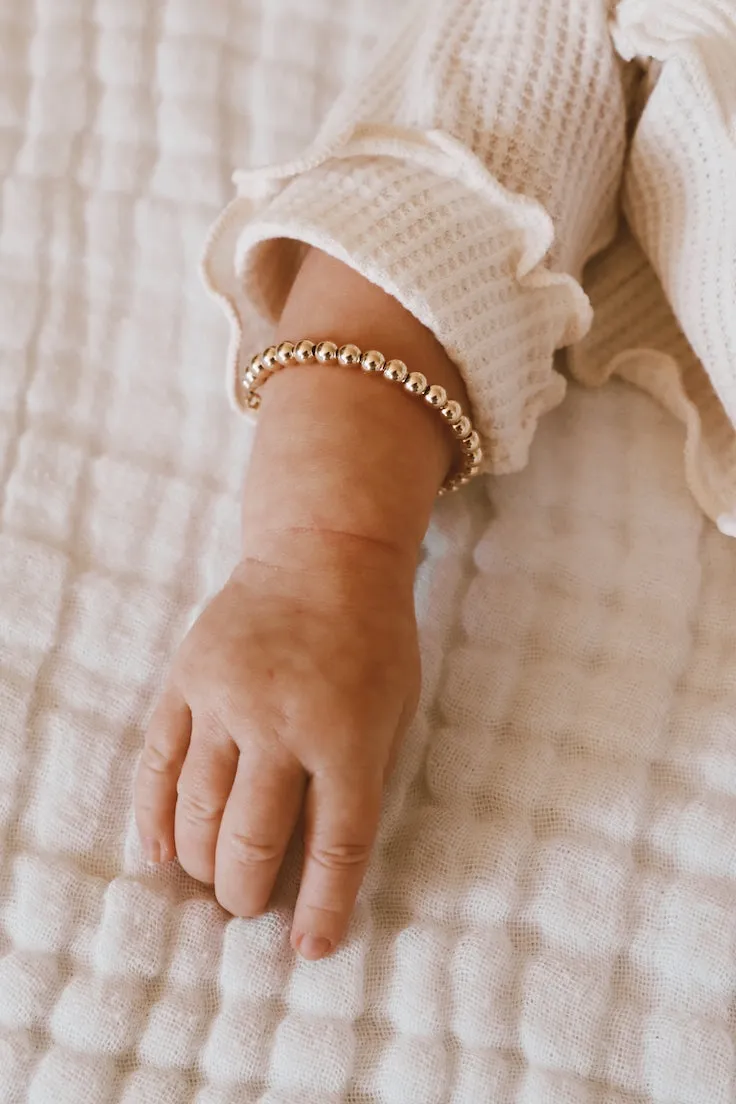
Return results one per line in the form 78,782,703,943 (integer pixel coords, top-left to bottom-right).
135,251,467,959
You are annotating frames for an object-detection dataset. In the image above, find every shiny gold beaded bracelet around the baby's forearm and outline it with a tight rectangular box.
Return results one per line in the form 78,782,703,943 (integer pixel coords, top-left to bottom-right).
243,339,483,495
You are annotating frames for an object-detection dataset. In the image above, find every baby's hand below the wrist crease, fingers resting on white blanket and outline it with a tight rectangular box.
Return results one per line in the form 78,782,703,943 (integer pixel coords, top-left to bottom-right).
136,532,419,958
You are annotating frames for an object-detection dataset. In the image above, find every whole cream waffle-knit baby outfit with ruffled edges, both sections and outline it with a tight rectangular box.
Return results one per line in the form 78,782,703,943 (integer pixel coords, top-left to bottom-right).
205,0,736,531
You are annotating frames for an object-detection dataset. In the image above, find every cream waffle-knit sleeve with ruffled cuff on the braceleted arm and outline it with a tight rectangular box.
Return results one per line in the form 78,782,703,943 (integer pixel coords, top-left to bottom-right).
205,0,626,473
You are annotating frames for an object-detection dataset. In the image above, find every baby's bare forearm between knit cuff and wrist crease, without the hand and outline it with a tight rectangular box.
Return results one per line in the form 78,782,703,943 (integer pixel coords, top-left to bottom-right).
243,251,467,565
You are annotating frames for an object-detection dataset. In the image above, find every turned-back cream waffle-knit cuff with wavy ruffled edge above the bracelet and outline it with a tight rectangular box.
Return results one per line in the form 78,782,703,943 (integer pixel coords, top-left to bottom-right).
204,127,591,474
